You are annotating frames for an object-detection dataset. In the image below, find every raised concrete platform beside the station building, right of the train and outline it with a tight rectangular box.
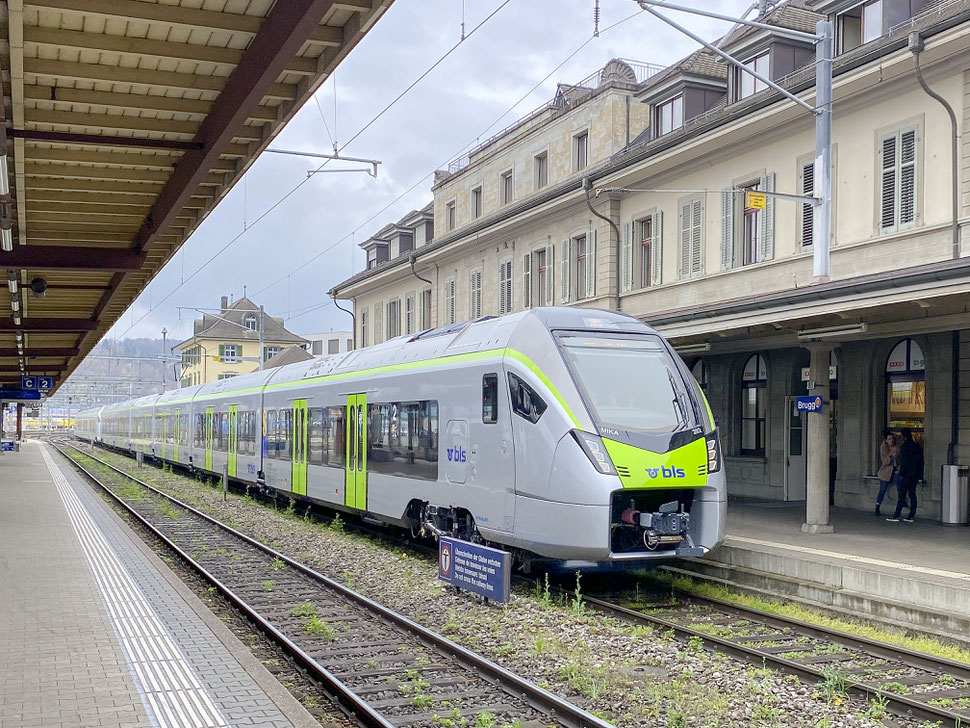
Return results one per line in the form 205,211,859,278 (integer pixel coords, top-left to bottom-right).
682,499,970,640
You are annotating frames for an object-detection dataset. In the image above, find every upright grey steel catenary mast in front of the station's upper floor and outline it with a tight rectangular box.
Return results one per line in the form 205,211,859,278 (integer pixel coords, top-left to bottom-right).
812,20,835,282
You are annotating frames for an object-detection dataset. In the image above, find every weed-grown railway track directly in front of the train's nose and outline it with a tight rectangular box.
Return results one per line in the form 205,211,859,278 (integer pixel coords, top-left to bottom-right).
585,594,970,728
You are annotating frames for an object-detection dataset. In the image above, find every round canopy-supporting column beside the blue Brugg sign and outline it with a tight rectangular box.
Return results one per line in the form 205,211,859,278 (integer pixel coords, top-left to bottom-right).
802,343,835,533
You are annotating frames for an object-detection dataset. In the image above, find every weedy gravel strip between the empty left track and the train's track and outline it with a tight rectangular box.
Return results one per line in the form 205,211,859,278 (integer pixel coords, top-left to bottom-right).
77,451,918,728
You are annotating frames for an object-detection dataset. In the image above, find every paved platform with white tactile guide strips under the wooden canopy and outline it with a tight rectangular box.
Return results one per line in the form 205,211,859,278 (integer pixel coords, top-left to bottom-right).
0,442,319,728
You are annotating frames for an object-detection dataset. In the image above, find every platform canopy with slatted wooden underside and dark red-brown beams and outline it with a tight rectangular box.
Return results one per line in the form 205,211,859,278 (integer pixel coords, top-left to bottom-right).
0,0,393,387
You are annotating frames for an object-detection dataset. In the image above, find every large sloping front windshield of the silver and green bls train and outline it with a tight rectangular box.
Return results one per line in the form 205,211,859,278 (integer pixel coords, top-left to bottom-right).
559,335,693,432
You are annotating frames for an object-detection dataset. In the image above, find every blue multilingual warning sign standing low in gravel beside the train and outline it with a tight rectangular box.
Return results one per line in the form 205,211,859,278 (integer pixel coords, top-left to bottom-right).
438,536,512,602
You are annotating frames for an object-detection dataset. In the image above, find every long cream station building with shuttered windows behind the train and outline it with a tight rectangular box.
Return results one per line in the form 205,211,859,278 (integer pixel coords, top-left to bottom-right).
334,0,970,530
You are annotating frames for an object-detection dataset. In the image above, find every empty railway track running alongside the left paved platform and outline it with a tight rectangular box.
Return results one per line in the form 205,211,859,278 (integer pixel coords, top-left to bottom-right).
52,443,608,728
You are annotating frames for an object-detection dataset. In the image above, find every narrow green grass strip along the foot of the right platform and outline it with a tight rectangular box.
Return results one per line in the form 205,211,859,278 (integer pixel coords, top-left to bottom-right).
642,571,970,665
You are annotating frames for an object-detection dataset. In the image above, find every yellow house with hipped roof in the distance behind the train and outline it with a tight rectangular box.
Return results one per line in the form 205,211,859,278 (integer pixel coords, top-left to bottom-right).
174,296,307,387
